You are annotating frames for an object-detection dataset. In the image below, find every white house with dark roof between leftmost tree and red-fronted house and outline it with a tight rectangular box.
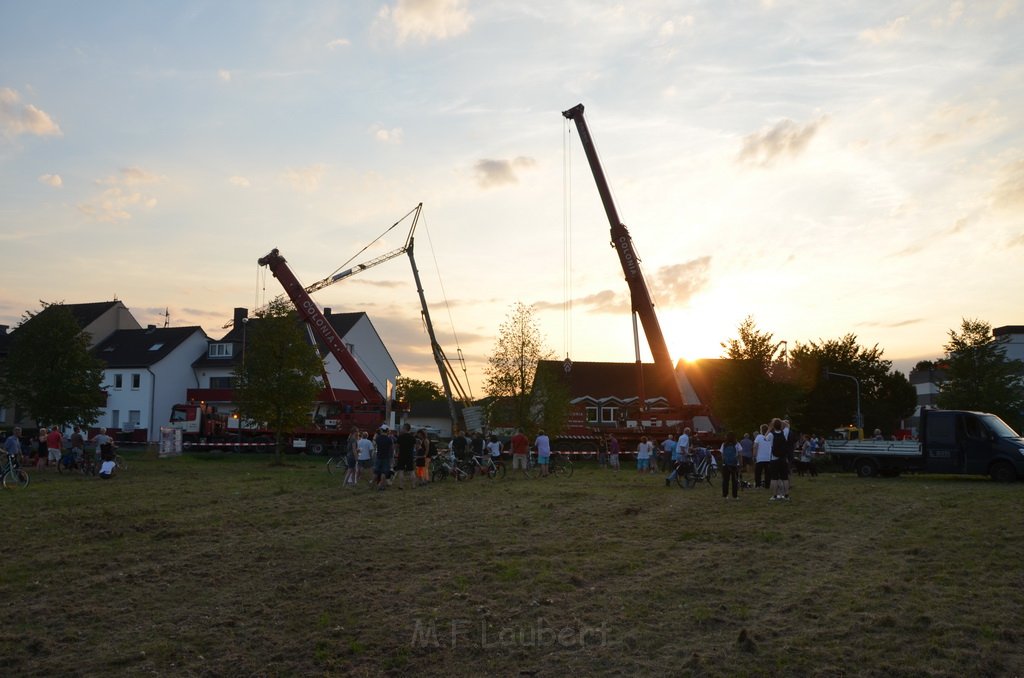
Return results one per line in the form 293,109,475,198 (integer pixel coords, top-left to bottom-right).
93,325,209,440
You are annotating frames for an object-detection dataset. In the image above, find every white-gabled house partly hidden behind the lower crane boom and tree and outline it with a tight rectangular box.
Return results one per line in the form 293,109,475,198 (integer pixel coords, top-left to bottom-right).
183,307,399,422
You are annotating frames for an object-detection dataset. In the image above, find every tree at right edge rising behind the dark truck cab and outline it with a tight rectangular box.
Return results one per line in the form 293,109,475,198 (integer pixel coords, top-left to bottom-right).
938,319,1024,430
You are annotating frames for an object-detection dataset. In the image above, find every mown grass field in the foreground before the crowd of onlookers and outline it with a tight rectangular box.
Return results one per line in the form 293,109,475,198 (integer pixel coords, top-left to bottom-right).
0,453,1024,676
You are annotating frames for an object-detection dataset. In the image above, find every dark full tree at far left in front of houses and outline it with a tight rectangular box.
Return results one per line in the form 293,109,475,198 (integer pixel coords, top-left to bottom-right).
0,302,105,426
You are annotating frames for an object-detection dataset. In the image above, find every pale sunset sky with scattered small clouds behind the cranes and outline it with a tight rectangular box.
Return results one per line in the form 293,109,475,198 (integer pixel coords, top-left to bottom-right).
0,0,1024,395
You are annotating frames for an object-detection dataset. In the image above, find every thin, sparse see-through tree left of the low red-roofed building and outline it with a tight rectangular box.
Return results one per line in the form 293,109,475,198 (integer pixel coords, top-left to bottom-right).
484,302,554,430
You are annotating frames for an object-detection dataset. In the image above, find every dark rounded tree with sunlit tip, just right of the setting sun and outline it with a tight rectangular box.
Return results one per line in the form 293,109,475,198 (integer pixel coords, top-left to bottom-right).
712,315,796,431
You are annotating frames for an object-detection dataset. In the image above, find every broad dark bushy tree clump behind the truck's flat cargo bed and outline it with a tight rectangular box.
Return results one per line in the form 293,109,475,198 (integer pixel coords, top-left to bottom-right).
791,334,918,433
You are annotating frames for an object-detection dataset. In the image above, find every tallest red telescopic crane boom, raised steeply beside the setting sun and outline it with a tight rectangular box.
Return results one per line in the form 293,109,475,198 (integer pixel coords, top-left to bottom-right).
562,103,684,408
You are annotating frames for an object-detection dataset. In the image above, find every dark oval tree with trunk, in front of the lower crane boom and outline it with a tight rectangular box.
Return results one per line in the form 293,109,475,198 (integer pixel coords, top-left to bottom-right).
236,300,324,464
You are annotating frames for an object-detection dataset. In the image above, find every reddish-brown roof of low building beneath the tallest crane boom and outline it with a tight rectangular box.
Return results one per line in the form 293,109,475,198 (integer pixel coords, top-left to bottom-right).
537,361,675,400
